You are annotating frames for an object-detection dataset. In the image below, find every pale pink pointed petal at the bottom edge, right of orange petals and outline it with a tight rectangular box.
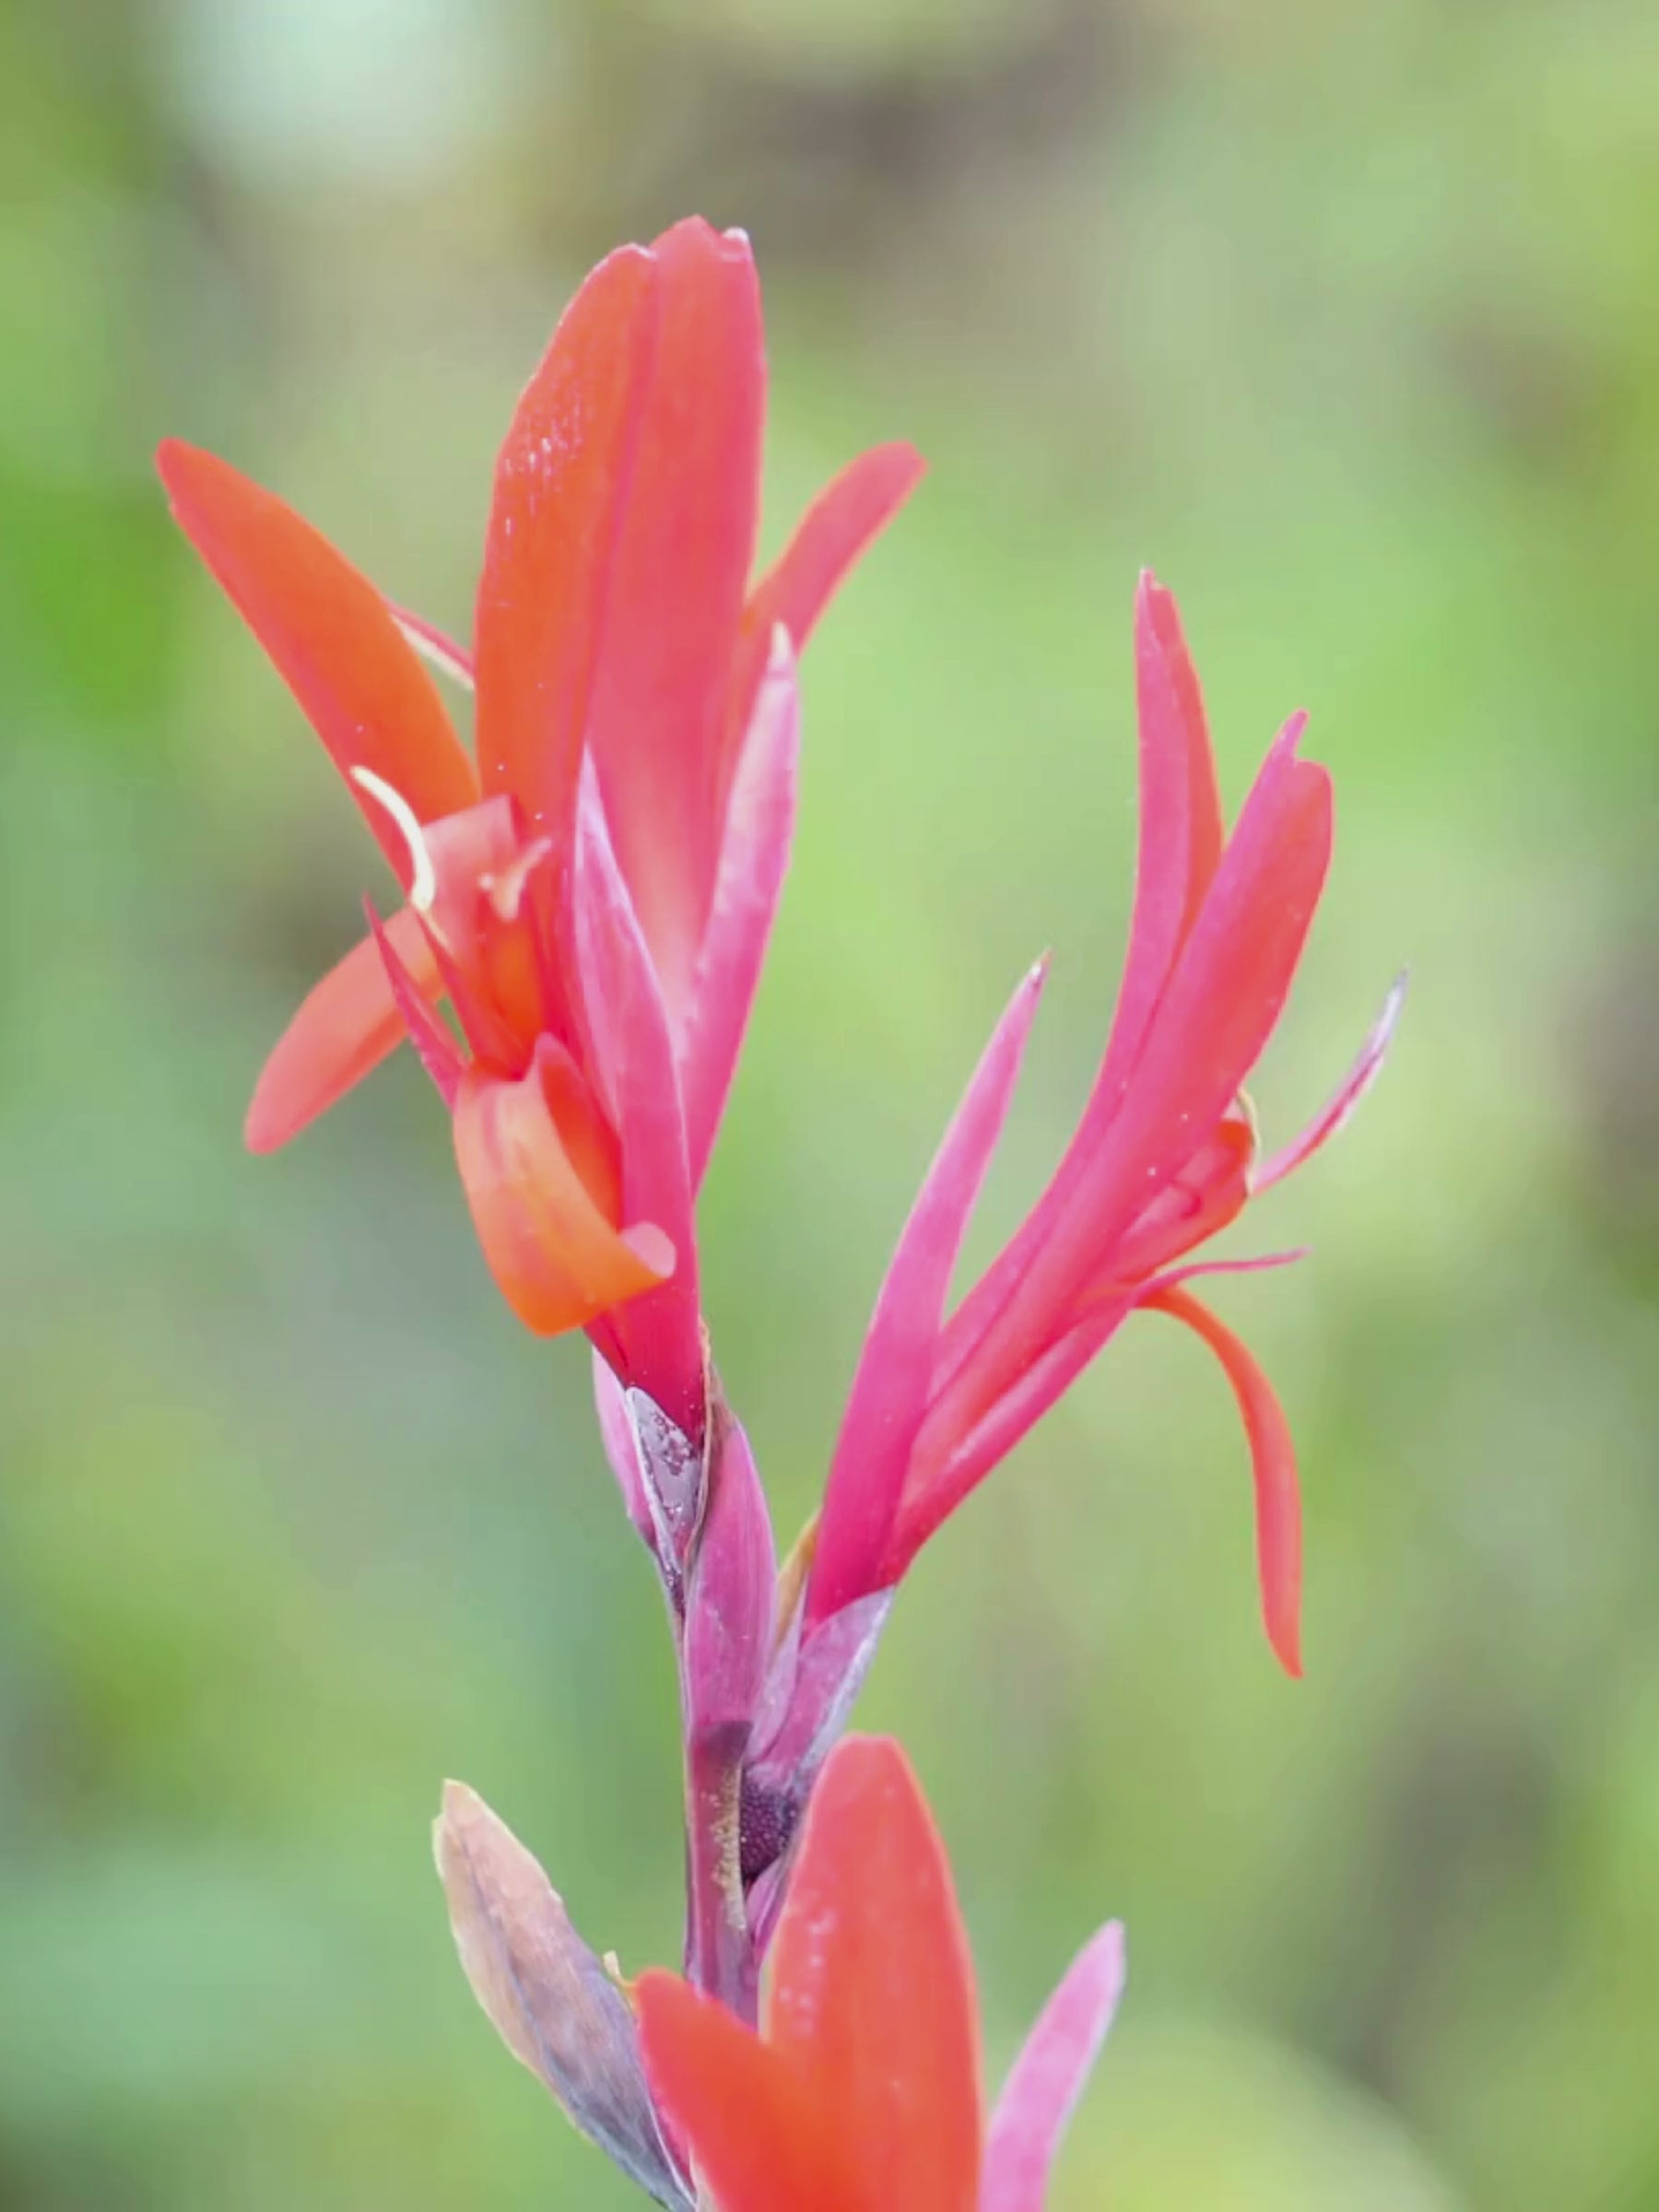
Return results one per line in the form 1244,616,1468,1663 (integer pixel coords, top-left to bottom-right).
980,1920,1124,2212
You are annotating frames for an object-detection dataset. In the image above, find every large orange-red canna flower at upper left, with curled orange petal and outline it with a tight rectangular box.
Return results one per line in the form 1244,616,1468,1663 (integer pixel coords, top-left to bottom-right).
157,221,920,1438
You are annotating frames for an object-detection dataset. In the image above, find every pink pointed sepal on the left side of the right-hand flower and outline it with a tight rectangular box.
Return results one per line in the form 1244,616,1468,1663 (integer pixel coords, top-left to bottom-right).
807,962,1046,1624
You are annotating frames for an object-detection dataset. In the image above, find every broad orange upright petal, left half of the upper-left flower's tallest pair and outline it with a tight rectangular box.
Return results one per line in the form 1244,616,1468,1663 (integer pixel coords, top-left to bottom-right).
476,245,657,842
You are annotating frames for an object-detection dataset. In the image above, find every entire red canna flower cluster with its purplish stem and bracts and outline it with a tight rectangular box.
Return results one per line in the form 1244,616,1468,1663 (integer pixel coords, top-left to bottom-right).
159,221,1398,2212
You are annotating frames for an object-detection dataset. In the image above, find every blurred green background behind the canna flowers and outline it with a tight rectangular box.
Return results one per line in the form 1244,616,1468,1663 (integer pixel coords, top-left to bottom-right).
0,0,1659,2212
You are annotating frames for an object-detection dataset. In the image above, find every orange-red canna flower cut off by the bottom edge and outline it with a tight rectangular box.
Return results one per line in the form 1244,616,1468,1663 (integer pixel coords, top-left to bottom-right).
635,1738,1124,2212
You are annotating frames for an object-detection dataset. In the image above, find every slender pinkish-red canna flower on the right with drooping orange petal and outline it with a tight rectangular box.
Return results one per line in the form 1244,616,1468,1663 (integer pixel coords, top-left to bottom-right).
803,575,1400,1675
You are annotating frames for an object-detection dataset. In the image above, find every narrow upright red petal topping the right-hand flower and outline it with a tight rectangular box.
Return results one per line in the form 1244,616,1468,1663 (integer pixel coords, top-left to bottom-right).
1097,569,1221,1100
